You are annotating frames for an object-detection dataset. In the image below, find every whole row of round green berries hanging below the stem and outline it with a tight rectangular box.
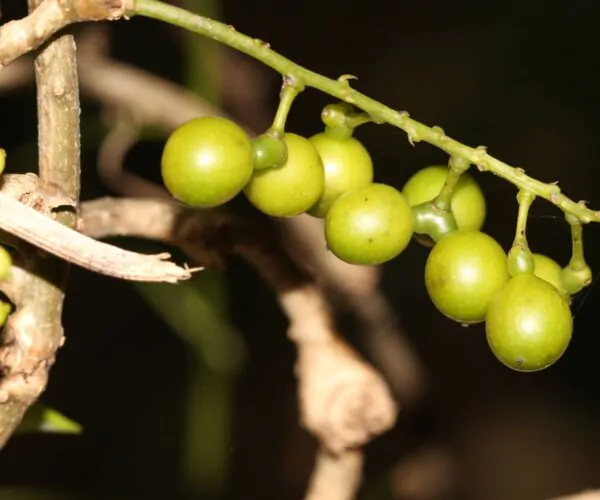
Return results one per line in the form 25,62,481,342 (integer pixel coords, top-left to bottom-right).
161,107,592,371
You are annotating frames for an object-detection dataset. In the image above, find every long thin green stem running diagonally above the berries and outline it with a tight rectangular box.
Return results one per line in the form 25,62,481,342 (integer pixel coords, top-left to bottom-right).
131,0,600,223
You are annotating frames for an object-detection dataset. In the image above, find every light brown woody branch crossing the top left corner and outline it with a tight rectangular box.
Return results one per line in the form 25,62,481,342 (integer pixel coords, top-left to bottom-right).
0,0,130,69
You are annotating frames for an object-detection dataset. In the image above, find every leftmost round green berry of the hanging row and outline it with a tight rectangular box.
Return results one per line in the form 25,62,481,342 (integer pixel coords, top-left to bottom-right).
161,116,254,207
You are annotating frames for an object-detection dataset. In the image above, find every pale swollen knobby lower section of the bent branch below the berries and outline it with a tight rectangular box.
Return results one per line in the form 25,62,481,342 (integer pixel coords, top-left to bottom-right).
276,284,396,455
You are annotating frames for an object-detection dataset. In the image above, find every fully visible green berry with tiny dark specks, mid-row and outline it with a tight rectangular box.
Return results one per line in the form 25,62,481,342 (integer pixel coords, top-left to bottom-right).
325,184,413,266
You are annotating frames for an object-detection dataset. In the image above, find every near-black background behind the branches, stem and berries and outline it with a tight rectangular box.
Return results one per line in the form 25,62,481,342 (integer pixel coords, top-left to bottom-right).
0,0,600,500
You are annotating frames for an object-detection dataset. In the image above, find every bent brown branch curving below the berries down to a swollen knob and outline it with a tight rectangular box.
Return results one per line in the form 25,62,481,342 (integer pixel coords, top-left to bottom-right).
80,198,398,500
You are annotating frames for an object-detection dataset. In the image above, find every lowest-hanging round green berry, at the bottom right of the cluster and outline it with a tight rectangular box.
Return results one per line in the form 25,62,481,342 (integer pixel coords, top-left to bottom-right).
485,274,573,372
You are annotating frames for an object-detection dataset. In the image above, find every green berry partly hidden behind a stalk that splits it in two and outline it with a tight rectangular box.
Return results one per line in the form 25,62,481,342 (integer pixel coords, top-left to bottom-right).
402,165,486,231
